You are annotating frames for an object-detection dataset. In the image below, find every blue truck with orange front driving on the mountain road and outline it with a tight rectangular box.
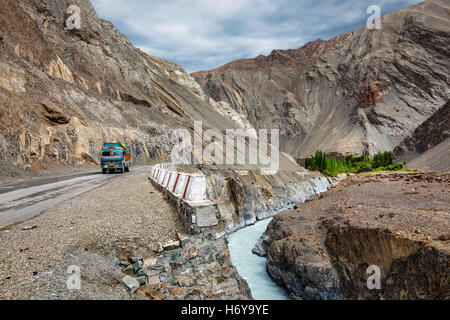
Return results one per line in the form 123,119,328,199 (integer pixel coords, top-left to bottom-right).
100,142,131,174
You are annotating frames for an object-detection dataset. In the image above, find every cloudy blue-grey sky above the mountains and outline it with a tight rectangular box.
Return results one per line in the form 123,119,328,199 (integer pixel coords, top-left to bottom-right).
91,0,421,72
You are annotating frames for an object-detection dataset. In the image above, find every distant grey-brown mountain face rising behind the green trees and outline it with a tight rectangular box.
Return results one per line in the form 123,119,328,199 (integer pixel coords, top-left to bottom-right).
193,0,450,158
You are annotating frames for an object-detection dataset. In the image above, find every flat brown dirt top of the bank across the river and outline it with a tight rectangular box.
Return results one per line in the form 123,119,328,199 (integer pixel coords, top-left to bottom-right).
269,173,450,251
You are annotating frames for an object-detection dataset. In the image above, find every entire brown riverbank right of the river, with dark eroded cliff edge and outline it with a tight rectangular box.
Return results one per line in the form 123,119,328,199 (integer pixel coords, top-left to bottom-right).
256,173,450,300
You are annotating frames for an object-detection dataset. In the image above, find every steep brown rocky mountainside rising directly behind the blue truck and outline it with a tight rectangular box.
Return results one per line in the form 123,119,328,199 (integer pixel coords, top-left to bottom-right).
0,0,243,175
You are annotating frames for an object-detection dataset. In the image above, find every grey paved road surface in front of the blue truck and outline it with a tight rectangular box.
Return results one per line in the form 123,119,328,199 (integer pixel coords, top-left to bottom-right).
0,167,150,227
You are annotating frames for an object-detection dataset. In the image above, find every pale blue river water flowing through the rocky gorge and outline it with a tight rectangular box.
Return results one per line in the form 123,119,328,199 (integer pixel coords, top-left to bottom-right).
228,219,289,300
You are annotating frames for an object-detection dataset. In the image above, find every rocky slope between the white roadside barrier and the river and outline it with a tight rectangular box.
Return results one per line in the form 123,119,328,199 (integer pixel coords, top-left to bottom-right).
202,168,337,233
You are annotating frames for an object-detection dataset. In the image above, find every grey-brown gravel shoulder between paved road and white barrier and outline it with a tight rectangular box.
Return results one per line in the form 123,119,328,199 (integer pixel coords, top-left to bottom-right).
0,170,182,299
